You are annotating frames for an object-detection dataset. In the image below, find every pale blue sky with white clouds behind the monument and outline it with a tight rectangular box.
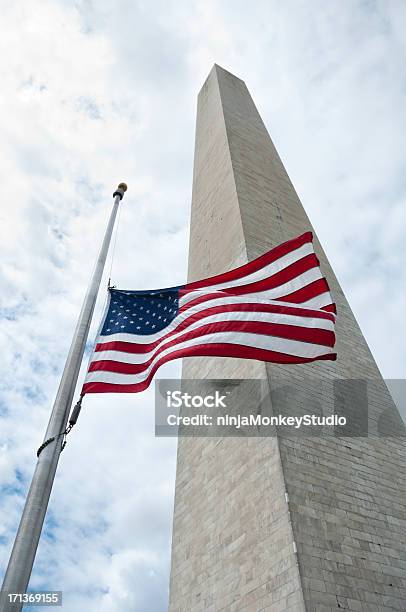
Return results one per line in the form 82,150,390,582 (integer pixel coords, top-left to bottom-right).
0,0,406,612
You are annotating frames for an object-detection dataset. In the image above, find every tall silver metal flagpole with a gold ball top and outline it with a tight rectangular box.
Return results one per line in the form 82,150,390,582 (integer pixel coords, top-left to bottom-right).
0,183,127,612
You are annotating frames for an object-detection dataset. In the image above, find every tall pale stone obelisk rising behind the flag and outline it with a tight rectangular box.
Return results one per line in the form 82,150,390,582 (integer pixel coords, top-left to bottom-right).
169,65,406,612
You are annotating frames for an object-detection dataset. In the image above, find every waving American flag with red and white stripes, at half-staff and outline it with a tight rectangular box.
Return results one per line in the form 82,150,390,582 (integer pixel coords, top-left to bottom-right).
82,232,336,394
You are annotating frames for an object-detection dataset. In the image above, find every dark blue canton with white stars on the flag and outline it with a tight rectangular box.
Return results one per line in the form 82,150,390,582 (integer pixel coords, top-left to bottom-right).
101,288,179,336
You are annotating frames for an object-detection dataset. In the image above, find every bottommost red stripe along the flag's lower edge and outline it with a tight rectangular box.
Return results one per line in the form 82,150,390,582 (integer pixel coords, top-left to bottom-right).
82,344,337,393
